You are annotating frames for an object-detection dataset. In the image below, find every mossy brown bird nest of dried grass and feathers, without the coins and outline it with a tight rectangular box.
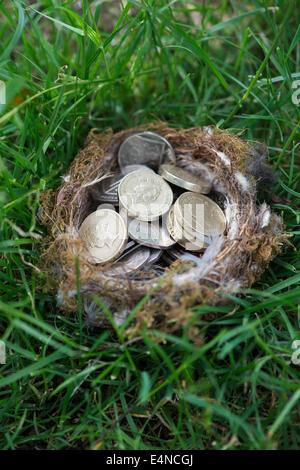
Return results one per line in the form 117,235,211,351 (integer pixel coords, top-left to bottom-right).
39,122,287,338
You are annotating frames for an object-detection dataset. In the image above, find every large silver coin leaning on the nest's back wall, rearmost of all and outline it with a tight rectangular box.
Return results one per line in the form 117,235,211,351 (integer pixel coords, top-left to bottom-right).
118,131,175,170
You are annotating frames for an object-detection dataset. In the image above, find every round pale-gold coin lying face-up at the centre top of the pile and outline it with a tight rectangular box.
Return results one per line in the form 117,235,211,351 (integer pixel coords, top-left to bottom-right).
118,170,173,221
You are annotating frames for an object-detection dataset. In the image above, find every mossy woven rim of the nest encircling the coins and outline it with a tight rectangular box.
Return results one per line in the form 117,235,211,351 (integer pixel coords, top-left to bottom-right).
41,122,286,336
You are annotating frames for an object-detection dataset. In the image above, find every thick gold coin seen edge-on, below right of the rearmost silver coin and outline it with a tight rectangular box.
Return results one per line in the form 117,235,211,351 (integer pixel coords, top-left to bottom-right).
159,164,211,194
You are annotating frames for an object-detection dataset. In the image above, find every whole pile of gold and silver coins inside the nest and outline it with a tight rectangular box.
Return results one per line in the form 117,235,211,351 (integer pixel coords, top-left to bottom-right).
79,132,226,275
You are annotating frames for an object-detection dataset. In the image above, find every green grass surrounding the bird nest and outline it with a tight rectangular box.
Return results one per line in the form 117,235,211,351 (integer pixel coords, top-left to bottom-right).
0,0,300,449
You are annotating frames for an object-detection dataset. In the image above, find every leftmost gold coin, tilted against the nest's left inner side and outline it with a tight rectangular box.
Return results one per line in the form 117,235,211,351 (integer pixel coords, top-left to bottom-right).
79,209,128,264
